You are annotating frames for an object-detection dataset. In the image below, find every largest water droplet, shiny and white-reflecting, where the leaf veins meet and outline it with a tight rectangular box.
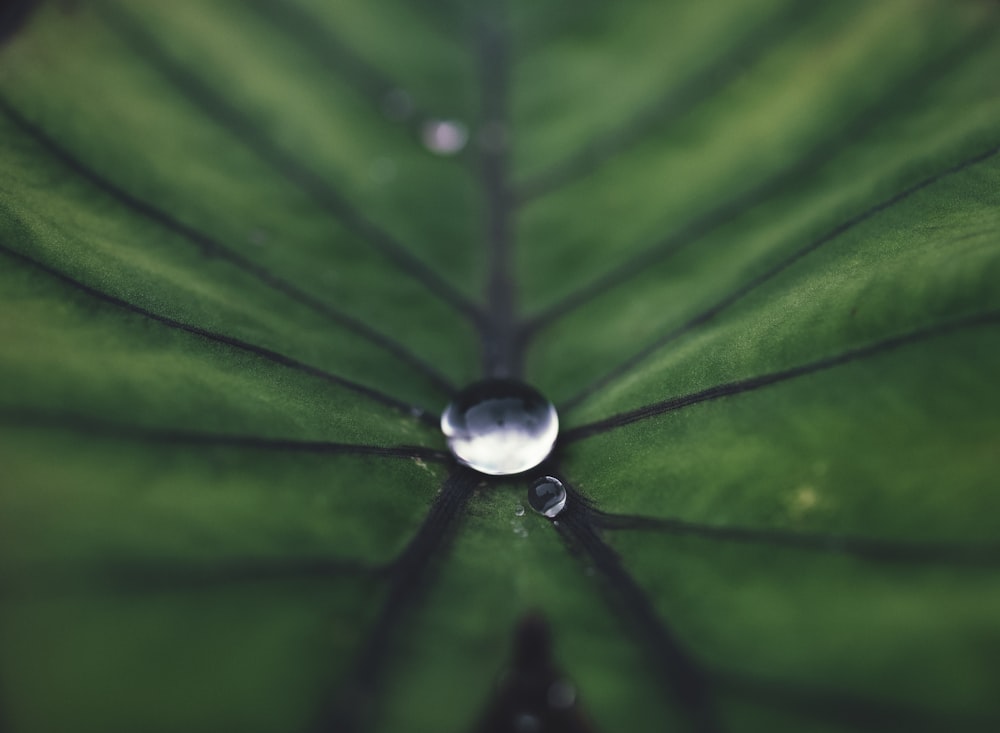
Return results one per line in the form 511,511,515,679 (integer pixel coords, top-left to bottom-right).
441,379,559,476
